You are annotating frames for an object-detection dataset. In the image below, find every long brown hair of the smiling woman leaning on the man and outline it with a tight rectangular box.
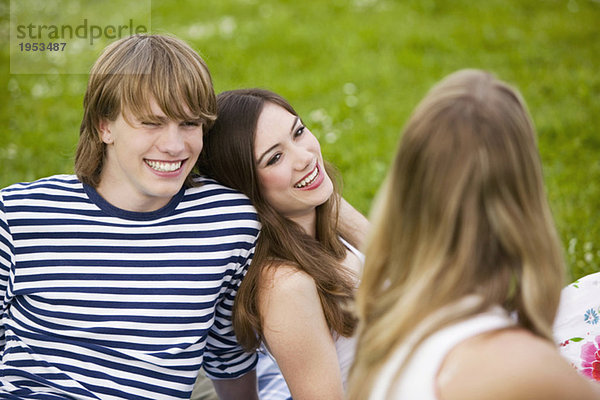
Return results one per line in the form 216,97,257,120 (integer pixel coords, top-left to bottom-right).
198,89,356,350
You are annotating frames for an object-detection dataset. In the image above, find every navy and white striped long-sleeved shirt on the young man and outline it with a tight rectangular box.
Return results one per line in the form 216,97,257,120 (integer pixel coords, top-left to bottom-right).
0,175,260,400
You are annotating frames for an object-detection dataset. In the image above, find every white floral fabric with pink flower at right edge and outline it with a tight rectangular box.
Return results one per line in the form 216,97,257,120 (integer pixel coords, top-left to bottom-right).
554,272,600,382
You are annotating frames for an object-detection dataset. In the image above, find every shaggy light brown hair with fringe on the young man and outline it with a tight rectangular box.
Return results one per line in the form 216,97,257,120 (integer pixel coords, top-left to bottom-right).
75,35,216,187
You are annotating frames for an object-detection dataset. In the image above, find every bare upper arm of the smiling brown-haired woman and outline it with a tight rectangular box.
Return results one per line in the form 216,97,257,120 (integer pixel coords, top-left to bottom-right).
259,266,344,400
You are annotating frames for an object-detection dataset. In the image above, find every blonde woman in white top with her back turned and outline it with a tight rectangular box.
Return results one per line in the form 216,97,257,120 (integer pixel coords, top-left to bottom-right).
349,70,600,400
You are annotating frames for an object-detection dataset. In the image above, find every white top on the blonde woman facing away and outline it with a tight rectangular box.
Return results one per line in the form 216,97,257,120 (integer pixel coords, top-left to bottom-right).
369,307,514,400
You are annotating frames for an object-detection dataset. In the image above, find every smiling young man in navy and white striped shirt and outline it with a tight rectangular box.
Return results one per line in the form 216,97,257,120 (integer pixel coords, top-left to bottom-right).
0,35,259,400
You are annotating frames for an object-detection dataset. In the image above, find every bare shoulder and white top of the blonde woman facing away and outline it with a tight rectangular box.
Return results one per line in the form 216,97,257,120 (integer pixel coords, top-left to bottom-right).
369,306,600,400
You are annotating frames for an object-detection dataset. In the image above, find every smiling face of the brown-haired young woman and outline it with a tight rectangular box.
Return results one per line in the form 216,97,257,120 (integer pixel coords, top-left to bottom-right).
254,102,333,220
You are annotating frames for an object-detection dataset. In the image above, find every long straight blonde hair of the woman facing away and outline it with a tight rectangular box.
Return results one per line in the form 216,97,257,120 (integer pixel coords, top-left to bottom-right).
350,70,564,399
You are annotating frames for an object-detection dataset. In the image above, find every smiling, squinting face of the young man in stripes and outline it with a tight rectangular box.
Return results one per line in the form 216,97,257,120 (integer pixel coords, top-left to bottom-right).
97,99,202,212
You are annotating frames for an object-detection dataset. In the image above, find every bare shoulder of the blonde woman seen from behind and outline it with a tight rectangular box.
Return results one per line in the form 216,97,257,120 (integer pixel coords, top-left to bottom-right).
437,329,600,400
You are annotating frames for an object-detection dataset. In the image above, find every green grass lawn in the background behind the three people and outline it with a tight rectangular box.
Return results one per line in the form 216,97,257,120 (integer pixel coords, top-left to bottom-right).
0,0,600,279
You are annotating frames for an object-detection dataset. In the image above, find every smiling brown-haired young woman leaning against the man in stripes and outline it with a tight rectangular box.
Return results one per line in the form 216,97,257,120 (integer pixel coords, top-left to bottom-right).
199,89,368,400
